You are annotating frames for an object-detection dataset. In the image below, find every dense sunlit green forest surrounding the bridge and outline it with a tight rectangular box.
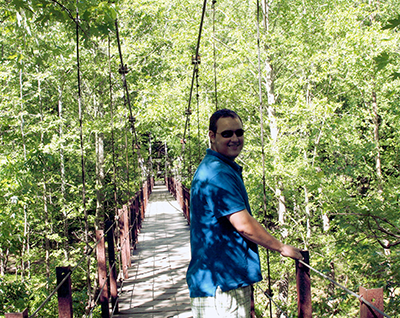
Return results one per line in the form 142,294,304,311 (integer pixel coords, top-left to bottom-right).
0,0,400,317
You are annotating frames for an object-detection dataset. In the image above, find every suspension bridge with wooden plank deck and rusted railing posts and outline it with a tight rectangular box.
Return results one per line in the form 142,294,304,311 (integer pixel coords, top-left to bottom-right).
5,178,391,318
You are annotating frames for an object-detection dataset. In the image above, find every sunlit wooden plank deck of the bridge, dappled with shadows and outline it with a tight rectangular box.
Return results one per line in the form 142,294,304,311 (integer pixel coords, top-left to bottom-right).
113,184,192,318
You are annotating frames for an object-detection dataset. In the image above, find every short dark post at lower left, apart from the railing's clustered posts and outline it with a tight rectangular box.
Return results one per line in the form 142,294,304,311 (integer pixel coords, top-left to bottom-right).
56,266,73,318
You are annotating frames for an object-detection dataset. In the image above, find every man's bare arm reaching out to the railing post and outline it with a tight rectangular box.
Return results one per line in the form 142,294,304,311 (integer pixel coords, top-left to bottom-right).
227,210,303,260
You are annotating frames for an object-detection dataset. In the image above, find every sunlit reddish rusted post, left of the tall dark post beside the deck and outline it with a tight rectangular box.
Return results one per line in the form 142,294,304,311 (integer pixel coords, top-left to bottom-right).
96,230,110,318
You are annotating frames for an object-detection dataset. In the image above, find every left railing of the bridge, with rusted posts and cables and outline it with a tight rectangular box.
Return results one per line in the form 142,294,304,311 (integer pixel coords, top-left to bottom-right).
5,178,154,318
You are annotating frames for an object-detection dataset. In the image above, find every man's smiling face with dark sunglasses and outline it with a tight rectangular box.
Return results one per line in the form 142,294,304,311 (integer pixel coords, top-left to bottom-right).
208,117,244,160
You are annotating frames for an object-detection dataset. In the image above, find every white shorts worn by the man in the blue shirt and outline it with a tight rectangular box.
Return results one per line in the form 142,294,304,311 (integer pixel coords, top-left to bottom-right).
190,286,252,318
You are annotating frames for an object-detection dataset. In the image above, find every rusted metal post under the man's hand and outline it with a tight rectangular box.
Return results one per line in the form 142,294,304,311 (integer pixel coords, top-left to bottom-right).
296,251,312,318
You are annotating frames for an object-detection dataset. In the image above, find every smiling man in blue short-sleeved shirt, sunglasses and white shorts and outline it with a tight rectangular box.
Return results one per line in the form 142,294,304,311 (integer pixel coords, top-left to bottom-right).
186,109,303,318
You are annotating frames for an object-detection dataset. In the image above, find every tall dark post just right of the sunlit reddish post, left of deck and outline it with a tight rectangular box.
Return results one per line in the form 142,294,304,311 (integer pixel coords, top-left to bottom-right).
106,221,118,313
